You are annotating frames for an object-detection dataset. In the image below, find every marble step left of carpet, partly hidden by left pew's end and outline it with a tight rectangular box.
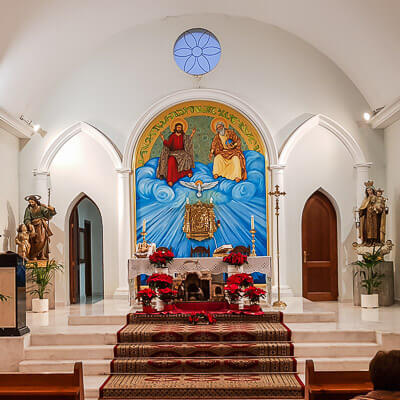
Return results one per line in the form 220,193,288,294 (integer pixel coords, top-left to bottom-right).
19,359,111,376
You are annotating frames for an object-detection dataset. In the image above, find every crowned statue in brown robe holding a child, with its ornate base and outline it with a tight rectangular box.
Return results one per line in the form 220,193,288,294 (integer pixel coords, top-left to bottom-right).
353,181,393,255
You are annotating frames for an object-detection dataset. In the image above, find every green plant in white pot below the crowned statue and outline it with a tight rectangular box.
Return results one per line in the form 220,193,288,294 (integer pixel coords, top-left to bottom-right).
353,247,384,308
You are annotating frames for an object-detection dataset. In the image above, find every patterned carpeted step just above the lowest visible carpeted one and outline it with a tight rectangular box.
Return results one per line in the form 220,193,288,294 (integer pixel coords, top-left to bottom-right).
111,357,297,374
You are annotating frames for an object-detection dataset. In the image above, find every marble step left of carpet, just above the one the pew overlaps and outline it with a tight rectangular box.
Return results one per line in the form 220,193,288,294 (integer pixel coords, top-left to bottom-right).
25,345,114,360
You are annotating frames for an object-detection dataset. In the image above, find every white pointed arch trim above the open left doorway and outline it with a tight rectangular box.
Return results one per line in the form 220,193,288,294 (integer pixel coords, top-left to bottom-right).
36,121,122,174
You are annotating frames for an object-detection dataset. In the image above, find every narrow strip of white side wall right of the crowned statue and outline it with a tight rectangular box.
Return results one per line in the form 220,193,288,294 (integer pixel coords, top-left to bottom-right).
384,121,400,299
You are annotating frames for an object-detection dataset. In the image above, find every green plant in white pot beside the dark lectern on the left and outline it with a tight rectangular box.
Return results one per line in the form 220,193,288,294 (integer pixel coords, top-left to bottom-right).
26,260,64,312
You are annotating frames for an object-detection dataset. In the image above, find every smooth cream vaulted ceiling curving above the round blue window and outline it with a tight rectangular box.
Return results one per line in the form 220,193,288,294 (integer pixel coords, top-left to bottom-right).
0,0,400,116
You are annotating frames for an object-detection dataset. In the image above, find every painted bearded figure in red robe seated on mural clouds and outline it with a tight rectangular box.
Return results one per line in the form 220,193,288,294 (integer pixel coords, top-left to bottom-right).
156,122,196,186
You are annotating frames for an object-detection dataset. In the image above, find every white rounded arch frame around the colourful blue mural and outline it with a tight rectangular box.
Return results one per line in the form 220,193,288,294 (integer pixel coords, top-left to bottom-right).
123,89,278,254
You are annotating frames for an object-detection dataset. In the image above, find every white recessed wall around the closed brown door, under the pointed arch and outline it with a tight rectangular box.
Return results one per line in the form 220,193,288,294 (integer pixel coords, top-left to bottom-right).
282,126,356,299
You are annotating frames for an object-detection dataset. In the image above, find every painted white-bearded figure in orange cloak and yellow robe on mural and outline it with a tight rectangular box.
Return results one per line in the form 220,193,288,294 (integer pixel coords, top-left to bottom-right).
208,121,247,182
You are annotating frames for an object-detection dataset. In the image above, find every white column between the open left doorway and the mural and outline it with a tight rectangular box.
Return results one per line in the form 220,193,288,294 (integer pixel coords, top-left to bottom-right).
114,169,131,298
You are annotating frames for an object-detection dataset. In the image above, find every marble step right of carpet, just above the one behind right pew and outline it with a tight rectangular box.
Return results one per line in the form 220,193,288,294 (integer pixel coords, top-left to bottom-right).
294,342,380,359
